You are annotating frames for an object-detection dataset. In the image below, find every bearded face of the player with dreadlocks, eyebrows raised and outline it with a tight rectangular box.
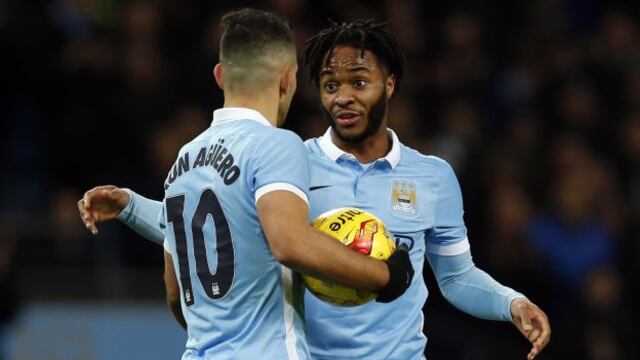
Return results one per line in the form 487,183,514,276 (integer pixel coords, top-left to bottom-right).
320,46,395,143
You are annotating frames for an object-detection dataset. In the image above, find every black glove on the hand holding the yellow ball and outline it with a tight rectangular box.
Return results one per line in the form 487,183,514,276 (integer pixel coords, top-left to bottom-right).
376,245,413,303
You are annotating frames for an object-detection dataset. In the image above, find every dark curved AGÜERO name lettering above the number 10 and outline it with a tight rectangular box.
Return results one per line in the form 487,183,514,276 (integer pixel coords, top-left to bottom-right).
164,139,240,190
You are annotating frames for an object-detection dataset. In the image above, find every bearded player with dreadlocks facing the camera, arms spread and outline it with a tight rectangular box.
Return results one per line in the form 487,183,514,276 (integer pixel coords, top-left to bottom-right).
79,20,551,360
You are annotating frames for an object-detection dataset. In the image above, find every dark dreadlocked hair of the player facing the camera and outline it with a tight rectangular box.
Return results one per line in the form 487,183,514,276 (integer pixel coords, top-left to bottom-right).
303,19,405,91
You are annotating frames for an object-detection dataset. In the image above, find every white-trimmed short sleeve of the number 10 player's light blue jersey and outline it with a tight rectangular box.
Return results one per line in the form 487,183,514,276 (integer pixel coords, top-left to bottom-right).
249,129,309,203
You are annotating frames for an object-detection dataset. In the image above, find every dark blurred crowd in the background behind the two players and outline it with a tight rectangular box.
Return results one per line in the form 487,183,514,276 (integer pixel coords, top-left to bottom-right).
0,0,640,360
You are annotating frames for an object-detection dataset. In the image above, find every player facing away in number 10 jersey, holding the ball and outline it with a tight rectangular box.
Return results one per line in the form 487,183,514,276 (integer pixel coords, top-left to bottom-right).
79,9,413,359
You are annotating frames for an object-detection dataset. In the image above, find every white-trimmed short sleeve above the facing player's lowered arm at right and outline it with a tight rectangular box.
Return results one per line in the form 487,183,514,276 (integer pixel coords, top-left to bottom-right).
427,163,469,256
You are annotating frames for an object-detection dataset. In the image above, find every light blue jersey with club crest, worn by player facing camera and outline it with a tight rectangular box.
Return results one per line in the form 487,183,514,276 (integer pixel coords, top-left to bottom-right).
305,130,469,360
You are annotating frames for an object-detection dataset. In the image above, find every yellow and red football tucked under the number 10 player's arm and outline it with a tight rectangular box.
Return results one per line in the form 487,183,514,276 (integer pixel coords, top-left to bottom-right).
302,208,396,306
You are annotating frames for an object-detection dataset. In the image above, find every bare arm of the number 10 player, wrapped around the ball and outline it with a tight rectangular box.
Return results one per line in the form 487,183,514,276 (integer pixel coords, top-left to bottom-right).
258,191,389,291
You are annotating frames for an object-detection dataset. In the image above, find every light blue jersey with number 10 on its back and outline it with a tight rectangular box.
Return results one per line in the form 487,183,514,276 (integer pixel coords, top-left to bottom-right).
160,108,309,359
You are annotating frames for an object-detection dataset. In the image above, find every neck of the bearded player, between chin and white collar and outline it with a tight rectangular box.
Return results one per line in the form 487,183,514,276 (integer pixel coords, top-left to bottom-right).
331,120,392,164
